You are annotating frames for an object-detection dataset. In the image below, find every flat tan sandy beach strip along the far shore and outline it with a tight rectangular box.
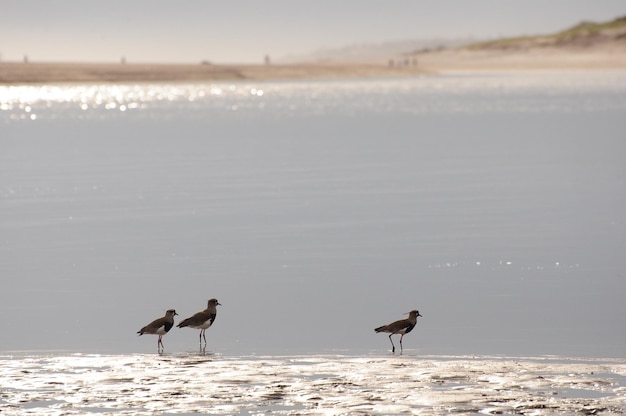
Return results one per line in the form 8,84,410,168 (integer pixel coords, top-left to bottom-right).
0,48,626,84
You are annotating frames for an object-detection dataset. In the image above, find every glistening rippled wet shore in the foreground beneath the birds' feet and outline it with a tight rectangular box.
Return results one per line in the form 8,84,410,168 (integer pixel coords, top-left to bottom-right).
0,352,626,415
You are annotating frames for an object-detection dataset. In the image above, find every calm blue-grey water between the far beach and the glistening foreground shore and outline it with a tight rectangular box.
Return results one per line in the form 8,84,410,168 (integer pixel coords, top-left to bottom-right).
0,72,626,358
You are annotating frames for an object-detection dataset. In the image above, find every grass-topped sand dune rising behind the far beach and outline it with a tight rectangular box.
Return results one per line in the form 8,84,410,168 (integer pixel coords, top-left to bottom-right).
465,16,626,51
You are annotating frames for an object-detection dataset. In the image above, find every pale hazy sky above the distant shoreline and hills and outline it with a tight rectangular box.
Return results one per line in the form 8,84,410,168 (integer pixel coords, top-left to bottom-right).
0,0,626,63
